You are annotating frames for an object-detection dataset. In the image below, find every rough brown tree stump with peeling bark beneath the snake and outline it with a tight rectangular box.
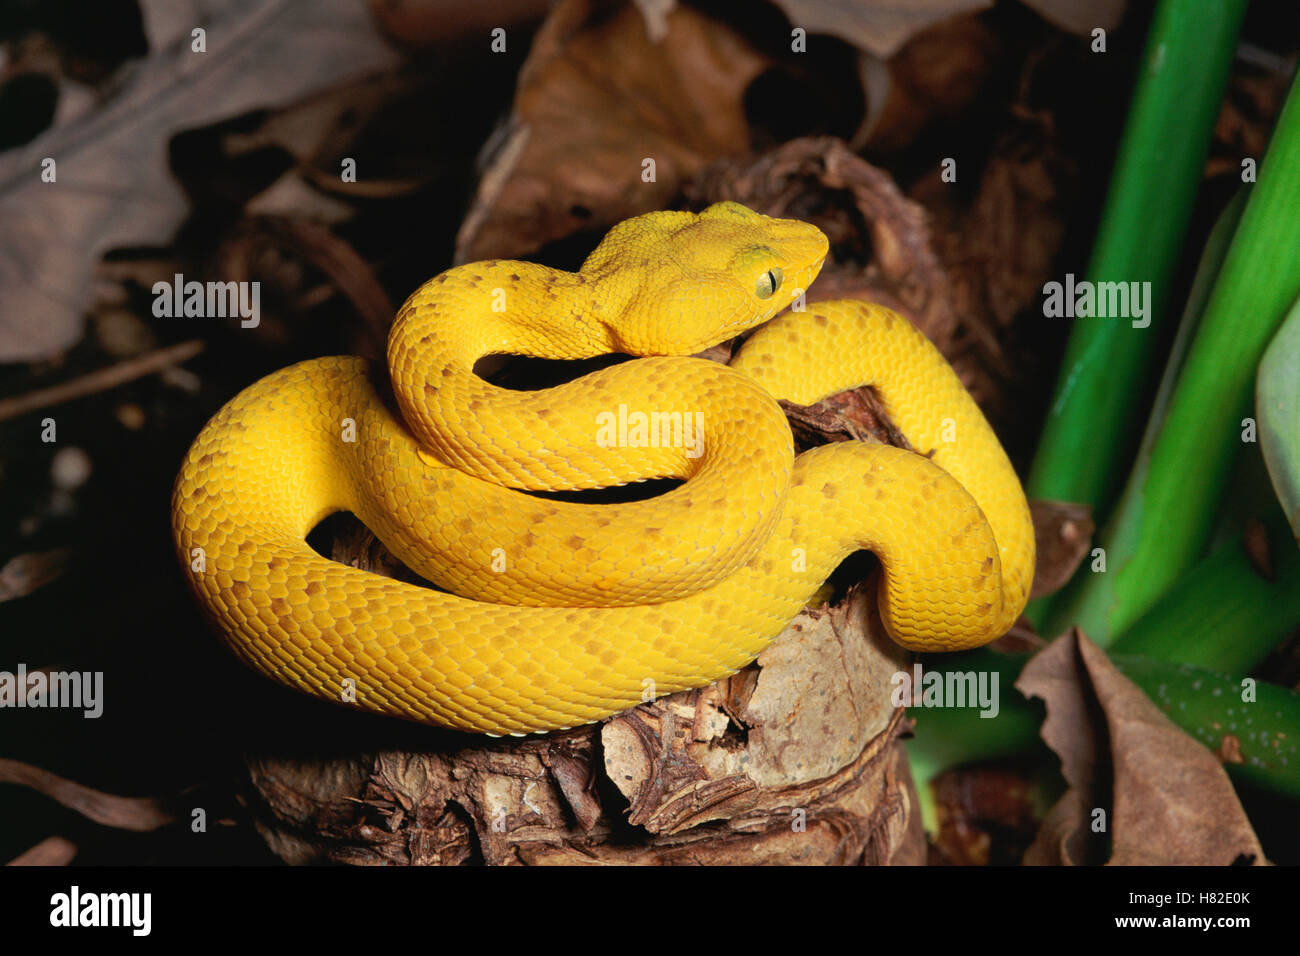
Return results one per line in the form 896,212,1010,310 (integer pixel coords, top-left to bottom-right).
244,587,926,865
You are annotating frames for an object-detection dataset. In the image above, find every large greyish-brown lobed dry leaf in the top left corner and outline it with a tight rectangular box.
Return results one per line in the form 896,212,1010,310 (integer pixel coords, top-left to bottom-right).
0,0,397,362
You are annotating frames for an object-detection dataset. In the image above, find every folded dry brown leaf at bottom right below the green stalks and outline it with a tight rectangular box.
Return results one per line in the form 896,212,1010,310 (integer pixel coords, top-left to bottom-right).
1015,628,1264,866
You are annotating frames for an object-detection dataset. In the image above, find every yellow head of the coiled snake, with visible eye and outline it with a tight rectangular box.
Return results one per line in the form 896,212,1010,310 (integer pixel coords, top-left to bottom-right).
582,202,828,355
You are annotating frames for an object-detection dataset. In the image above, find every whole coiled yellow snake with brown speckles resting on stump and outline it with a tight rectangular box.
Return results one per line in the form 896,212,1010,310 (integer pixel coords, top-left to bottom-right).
172,203,1034,735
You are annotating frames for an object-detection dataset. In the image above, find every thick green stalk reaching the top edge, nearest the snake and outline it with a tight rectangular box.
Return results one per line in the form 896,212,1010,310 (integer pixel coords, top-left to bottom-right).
1026,0,1247,514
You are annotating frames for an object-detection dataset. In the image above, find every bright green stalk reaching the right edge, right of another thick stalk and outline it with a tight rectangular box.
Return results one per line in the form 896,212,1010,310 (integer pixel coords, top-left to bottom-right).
1049,74,1300,646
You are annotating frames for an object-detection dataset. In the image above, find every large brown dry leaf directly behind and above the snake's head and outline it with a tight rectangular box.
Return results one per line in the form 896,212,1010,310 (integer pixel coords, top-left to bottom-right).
455,0,767,263
